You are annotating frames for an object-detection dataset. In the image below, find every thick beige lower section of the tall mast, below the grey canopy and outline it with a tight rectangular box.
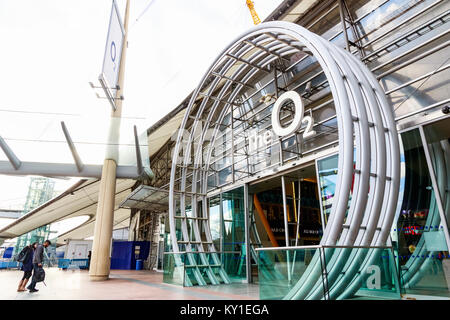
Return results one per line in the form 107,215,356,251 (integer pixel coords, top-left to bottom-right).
89,159,117,281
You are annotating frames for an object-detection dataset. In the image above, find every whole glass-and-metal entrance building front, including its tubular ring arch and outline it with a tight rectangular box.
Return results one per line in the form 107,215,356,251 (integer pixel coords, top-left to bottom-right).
129,0,450,299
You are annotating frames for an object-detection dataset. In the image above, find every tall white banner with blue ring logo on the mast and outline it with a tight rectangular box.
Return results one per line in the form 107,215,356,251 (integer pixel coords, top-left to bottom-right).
99,0,125,110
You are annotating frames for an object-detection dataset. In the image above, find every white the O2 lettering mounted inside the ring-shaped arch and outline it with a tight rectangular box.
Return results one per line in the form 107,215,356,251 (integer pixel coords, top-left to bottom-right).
249,91,316,153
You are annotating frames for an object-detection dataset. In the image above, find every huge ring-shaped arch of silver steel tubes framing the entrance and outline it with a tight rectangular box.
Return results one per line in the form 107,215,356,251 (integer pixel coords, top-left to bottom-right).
169,21,400,299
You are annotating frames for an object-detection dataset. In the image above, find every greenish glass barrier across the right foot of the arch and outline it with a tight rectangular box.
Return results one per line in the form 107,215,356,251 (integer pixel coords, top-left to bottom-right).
258,247,401,300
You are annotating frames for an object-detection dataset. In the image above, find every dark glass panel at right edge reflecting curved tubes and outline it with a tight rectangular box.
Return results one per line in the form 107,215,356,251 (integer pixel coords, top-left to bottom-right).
394,119,450,296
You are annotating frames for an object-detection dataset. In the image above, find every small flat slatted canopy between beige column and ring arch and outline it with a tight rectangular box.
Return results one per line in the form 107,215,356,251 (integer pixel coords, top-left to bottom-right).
119,185,176,212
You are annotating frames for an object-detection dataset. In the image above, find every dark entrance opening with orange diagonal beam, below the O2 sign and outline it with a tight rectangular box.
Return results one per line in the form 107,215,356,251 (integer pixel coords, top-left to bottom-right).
249,164,323,247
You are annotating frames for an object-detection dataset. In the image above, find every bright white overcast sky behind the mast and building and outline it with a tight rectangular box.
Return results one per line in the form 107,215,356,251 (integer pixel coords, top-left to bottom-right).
0,0,282,227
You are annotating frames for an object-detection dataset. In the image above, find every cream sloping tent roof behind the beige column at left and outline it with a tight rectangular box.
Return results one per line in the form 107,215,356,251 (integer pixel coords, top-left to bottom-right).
0,179,135,244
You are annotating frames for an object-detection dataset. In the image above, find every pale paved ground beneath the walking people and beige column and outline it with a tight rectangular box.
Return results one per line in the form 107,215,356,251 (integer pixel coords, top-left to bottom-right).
0,268,259,300
